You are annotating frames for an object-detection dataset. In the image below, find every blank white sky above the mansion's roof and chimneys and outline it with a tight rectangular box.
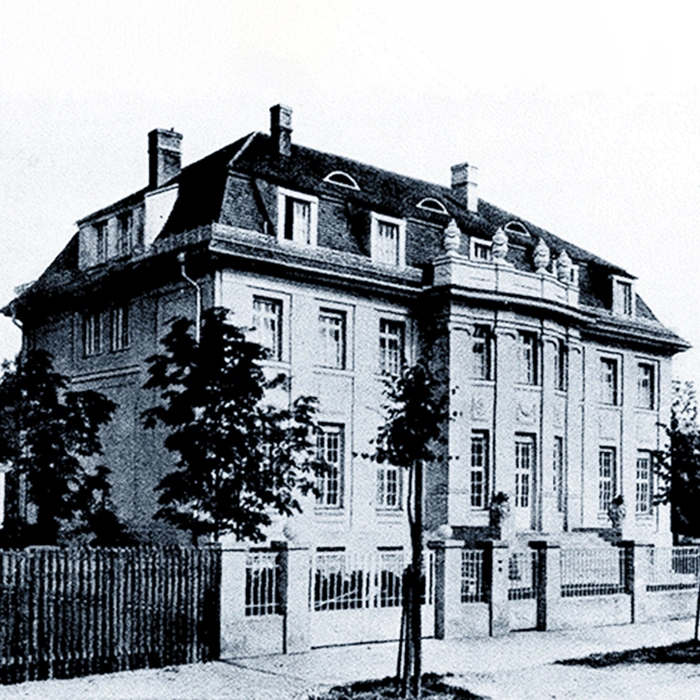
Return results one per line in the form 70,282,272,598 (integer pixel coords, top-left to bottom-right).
0,0,700,385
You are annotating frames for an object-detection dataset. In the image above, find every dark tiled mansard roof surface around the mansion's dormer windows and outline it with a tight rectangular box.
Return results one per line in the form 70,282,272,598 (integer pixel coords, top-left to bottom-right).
2,121,684,356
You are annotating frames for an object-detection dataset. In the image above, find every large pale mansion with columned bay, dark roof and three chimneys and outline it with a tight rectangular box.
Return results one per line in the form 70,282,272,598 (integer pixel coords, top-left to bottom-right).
5,106,686,551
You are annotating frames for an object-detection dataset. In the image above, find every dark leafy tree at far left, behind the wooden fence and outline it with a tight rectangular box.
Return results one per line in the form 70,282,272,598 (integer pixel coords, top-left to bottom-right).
0,350,118,546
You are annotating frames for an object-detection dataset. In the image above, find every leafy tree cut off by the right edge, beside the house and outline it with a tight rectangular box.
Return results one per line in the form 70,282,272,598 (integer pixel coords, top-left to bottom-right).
654,382,700,537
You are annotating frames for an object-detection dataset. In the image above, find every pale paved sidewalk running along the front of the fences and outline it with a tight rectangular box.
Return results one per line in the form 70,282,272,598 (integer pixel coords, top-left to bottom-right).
0,620,700,700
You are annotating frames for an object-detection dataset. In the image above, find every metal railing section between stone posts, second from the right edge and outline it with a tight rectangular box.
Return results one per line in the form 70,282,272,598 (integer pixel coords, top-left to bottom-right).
561,547,626,598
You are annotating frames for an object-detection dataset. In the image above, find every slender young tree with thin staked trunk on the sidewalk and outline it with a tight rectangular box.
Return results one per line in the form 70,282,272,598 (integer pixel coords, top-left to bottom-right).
374,359,446,698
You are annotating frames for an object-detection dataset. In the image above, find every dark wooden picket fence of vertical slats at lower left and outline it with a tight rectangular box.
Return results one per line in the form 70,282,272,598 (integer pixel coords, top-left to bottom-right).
0,547,221,683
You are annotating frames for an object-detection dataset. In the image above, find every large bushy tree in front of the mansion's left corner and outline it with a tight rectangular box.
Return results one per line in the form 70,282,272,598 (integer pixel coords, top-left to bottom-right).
143,308,325,541
